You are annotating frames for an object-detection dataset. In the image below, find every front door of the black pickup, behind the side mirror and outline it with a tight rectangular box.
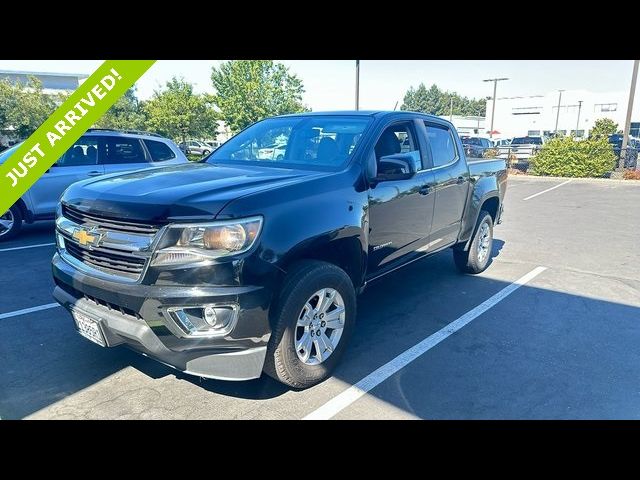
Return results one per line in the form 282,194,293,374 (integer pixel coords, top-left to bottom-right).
367,121,435,277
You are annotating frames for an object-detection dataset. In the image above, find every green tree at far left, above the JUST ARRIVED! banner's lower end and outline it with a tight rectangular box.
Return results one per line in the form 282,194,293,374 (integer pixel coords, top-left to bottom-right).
0,77,61,139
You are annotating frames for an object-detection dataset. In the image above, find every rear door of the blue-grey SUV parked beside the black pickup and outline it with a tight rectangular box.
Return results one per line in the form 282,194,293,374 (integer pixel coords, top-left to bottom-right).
98,135,155,173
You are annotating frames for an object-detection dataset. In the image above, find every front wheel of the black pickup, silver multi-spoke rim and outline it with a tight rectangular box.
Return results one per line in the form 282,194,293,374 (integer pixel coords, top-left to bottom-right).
264,260,356,388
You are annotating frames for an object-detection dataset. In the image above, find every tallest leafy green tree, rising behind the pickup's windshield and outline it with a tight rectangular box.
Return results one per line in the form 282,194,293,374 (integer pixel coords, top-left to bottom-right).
211,60,308,132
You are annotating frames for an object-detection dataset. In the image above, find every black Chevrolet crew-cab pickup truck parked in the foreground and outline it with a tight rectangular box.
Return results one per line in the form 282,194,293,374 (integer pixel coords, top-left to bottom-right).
53,111,507,388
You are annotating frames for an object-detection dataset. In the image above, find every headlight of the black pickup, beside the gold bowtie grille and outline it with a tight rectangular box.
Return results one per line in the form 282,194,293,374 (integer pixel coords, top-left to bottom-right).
151,217,262,266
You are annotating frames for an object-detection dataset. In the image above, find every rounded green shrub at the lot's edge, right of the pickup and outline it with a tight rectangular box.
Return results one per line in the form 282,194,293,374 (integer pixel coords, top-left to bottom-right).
529,137,616,177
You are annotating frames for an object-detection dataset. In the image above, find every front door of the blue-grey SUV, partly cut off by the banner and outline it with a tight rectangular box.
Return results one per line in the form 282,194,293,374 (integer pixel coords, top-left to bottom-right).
29,136,104,218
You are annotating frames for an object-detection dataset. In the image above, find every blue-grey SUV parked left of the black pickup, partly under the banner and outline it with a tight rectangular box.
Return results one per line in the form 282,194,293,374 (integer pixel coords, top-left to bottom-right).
0,129,187,241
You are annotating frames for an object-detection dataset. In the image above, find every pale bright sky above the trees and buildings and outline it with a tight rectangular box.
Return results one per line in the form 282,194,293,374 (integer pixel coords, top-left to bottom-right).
0,60,640,112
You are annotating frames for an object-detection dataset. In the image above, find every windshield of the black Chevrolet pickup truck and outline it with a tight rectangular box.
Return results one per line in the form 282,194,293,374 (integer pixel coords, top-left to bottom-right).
206,115,371,170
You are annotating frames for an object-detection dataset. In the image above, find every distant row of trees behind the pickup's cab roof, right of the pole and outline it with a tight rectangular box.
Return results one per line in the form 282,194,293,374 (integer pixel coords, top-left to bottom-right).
401,83,486,116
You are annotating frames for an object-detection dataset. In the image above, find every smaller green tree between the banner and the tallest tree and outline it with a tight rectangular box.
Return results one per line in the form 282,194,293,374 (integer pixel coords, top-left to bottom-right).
143,77,217,141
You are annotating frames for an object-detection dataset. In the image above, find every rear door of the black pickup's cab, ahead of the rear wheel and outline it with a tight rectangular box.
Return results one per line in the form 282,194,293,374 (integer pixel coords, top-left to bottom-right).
424,121,470,250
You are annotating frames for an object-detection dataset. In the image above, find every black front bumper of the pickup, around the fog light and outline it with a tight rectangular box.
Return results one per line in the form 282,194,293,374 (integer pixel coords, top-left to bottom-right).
52,254,271,380
